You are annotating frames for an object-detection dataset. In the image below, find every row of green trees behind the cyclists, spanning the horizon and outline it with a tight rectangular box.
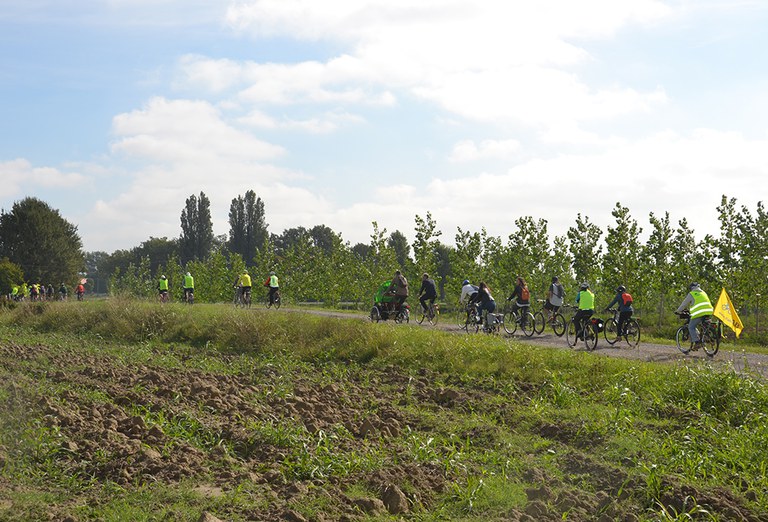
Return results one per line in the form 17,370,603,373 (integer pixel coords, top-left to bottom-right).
0,191,768,336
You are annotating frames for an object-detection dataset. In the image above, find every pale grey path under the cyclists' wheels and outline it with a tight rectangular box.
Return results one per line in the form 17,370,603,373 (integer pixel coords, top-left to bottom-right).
289,309,768,378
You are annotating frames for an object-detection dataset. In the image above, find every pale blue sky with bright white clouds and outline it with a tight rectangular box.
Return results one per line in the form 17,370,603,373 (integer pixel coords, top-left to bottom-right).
0,0,768,253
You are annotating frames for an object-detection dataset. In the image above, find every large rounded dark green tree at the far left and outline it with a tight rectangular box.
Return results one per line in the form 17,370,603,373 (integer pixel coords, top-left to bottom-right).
0,197,84,284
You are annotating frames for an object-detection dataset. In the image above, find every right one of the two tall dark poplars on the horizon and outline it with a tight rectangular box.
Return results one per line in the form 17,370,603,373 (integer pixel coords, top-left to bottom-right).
227,190,269,264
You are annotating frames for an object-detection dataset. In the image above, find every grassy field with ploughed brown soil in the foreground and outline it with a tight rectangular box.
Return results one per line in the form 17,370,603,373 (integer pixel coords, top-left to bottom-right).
0,301,768,521
